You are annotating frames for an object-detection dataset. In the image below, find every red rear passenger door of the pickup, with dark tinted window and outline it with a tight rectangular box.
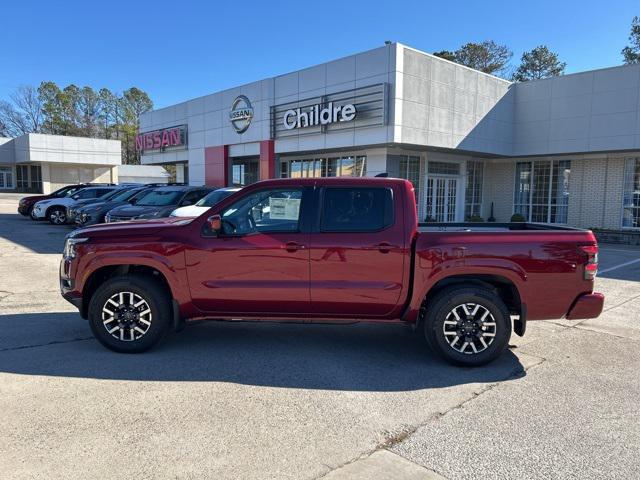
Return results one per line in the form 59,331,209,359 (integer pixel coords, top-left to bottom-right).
310,186,408,318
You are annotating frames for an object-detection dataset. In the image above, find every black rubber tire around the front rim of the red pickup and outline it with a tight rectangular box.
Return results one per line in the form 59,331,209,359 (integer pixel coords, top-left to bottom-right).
89,275,172,353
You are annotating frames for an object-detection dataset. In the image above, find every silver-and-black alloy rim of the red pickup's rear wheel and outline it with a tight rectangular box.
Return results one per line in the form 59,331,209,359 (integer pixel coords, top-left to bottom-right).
442,303,497,355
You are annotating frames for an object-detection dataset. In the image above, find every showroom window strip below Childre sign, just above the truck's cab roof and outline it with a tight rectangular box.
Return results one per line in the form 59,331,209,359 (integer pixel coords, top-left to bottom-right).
280,155,367,178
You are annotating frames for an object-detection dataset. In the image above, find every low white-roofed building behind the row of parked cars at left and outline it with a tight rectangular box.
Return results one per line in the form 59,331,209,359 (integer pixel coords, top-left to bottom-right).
0,133,169,194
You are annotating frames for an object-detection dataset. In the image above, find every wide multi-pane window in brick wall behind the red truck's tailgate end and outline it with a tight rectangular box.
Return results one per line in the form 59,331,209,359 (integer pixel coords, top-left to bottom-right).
513,160,571,223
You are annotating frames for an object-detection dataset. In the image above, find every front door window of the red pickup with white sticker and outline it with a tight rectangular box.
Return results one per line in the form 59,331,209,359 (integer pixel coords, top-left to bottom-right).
222,189,302,235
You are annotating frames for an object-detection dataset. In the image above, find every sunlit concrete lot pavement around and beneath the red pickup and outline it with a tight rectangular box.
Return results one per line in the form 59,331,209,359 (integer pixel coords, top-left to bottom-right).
0,194,640,478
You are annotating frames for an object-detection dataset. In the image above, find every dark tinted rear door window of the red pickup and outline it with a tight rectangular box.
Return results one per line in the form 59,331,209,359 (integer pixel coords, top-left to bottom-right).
320,187,393,232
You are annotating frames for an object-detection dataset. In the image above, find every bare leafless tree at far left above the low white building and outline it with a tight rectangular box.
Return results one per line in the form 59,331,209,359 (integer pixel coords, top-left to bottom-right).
0,85,43,137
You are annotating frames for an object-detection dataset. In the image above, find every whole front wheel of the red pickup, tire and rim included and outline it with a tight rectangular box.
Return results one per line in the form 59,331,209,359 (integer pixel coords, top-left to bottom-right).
89,275,171,353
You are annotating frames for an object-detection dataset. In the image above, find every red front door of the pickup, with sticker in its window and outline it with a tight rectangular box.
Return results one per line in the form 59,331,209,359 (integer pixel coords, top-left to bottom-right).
186,187,313,316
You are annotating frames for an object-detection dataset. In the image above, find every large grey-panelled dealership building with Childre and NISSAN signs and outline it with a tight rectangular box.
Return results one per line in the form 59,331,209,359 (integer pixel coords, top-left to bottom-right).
136,43,640,230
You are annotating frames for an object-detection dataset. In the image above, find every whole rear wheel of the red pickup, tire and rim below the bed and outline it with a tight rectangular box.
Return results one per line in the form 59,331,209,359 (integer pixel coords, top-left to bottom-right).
424,285,511,367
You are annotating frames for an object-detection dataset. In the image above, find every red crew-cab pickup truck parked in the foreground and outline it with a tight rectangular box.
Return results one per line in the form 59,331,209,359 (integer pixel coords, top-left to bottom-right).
60,178,604,366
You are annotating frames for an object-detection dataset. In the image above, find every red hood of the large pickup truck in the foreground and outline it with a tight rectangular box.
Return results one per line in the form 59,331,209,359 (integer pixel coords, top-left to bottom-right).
70,217,193,239
